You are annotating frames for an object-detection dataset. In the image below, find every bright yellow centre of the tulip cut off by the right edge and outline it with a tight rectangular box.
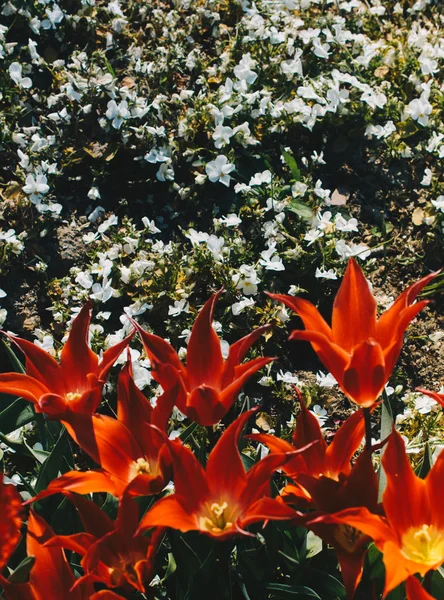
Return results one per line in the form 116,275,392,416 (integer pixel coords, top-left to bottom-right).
401,525,444,567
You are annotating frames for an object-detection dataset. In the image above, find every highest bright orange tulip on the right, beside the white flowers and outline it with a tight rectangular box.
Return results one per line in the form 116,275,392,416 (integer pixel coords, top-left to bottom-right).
270,258,437,408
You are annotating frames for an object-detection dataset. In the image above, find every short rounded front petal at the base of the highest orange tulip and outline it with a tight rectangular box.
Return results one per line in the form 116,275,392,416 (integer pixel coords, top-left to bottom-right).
338,339,390,408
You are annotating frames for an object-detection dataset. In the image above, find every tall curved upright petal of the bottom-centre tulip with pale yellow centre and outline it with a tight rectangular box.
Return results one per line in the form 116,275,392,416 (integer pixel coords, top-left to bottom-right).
206,408,257,501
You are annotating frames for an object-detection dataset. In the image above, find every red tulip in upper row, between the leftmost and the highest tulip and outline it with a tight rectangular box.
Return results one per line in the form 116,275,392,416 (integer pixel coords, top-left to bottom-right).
134,290,274,426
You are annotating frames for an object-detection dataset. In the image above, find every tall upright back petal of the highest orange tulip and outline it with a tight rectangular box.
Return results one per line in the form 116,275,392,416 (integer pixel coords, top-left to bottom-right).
331,258,376,352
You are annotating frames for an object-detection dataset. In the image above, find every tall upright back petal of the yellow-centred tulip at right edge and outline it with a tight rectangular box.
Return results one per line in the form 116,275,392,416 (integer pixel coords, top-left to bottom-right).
382,430,426,536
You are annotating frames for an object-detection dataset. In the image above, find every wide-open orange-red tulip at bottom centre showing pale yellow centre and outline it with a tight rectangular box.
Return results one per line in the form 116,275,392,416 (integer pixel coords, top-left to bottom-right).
139,409,297,540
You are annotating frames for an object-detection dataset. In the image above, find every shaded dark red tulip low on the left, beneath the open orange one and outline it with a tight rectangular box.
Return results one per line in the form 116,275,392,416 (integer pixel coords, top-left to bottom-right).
45,493,164,592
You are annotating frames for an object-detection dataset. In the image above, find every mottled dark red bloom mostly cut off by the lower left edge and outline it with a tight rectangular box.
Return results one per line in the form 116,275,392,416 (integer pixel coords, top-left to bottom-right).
0,473,22,572
